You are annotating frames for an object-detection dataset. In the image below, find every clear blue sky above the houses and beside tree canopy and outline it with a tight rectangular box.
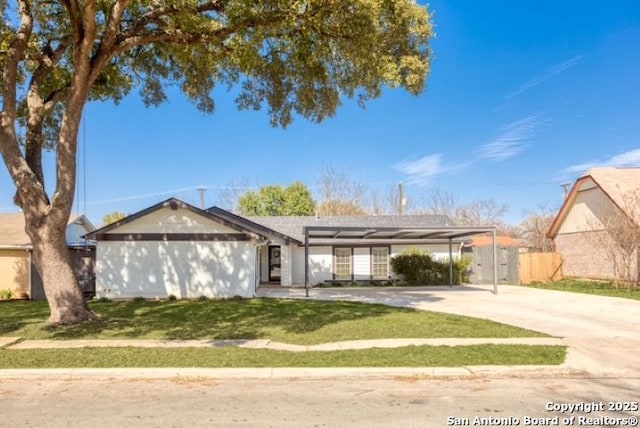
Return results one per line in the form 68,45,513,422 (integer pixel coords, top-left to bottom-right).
0,0,640,224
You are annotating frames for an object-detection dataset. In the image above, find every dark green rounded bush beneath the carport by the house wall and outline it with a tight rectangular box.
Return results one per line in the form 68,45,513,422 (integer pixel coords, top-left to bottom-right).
391,249,471,285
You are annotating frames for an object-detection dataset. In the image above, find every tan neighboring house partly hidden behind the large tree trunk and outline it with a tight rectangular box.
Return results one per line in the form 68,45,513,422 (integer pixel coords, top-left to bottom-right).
0,213,95,300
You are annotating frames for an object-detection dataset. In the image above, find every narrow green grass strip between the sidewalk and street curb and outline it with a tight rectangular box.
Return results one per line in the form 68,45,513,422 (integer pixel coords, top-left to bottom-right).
0,345,566,369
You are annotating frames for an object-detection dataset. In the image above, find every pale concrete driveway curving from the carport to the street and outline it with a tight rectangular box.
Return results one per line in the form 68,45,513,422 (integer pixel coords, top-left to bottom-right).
264,286,640,375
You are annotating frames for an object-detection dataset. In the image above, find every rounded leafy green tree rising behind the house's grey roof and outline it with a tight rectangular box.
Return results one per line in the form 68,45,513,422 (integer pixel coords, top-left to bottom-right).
238,182,315,216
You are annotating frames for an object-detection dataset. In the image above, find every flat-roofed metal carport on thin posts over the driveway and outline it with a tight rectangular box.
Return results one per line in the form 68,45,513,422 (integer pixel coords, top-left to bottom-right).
304,226,498,297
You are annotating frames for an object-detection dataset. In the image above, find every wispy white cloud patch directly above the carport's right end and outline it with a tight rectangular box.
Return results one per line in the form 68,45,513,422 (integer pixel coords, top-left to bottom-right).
478,115,543,161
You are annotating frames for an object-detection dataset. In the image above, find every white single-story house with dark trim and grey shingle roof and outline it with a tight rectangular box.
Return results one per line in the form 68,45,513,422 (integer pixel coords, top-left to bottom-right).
87,198,494,298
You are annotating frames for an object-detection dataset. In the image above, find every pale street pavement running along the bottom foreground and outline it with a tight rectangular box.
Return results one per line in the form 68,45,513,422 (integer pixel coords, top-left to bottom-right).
0,377,640,428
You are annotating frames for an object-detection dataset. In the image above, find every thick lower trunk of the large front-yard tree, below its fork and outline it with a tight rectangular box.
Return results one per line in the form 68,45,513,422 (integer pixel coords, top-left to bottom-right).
27,212,98,324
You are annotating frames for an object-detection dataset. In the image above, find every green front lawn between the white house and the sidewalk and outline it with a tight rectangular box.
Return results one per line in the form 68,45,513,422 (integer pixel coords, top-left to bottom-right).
0,299,547,345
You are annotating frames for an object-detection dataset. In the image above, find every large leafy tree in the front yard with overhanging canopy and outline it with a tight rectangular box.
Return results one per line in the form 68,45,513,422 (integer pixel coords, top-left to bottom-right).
0,0,433,323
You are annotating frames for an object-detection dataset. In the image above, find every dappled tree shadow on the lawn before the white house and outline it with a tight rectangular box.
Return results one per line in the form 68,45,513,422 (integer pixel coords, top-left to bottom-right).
44,298,404,339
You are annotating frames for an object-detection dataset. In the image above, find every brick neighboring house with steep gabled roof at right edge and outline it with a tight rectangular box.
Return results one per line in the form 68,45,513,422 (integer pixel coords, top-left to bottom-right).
548,168,640,279
